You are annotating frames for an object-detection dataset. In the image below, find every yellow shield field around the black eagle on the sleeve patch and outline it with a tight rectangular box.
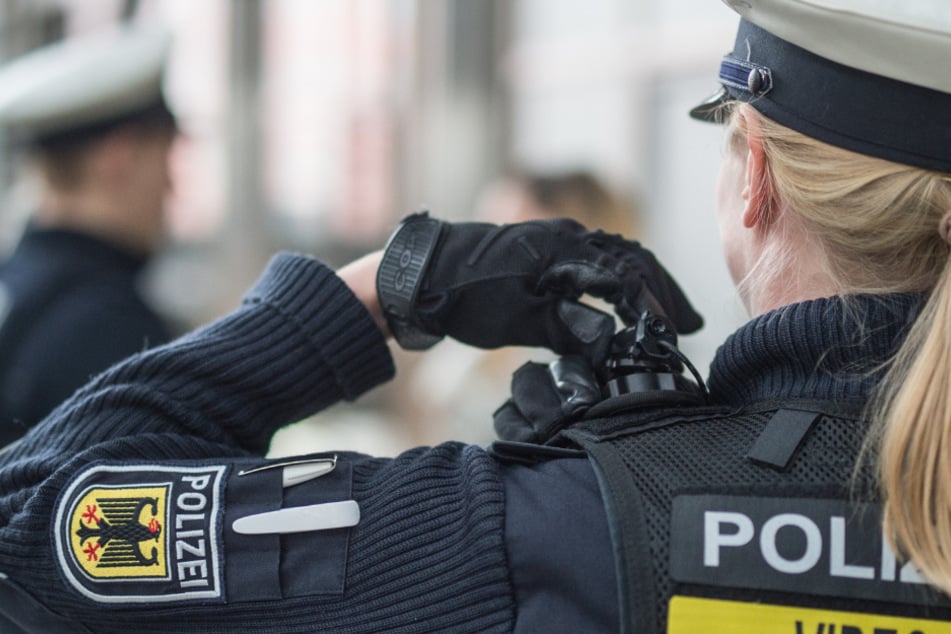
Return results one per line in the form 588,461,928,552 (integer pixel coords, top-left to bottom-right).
69,485,168,579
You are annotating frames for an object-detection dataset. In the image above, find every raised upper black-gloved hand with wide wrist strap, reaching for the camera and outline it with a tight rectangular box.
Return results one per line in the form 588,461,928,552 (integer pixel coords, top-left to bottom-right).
377,214,703,364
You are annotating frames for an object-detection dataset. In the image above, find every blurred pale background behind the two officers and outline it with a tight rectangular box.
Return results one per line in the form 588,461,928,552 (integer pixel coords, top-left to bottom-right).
0,0,744,455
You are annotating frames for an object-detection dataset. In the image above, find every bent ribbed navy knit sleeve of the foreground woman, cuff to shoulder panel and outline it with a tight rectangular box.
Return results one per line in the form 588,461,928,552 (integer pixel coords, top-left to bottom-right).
0,255,515,633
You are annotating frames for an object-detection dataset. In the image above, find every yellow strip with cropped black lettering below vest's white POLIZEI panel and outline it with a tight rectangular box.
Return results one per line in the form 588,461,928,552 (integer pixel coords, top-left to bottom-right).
667,597,951,634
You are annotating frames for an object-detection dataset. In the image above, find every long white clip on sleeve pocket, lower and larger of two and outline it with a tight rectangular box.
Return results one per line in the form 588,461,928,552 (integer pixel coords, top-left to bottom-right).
231,500,360,535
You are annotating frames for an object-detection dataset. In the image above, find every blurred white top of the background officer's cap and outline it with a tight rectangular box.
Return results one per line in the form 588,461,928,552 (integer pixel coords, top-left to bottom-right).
0,25,171,140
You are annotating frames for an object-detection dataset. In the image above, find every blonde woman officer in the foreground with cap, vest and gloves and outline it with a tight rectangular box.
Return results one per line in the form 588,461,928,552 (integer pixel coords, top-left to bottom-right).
0,0,951,634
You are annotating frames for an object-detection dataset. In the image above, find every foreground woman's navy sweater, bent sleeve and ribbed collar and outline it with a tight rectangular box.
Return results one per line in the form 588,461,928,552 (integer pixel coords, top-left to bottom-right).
0,249,915,632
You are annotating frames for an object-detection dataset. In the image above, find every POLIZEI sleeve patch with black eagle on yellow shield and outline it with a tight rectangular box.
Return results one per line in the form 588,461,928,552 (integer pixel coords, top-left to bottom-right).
53,464,226,603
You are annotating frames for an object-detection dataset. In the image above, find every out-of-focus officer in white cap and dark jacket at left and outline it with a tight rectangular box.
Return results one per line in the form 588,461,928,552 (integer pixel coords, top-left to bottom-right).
0,27,176,445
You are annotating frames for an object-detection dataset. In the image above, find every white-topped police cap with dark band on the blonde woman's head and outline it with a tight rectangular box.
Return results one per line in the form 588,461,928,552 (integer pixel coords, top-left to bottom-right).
691,0,951,172
